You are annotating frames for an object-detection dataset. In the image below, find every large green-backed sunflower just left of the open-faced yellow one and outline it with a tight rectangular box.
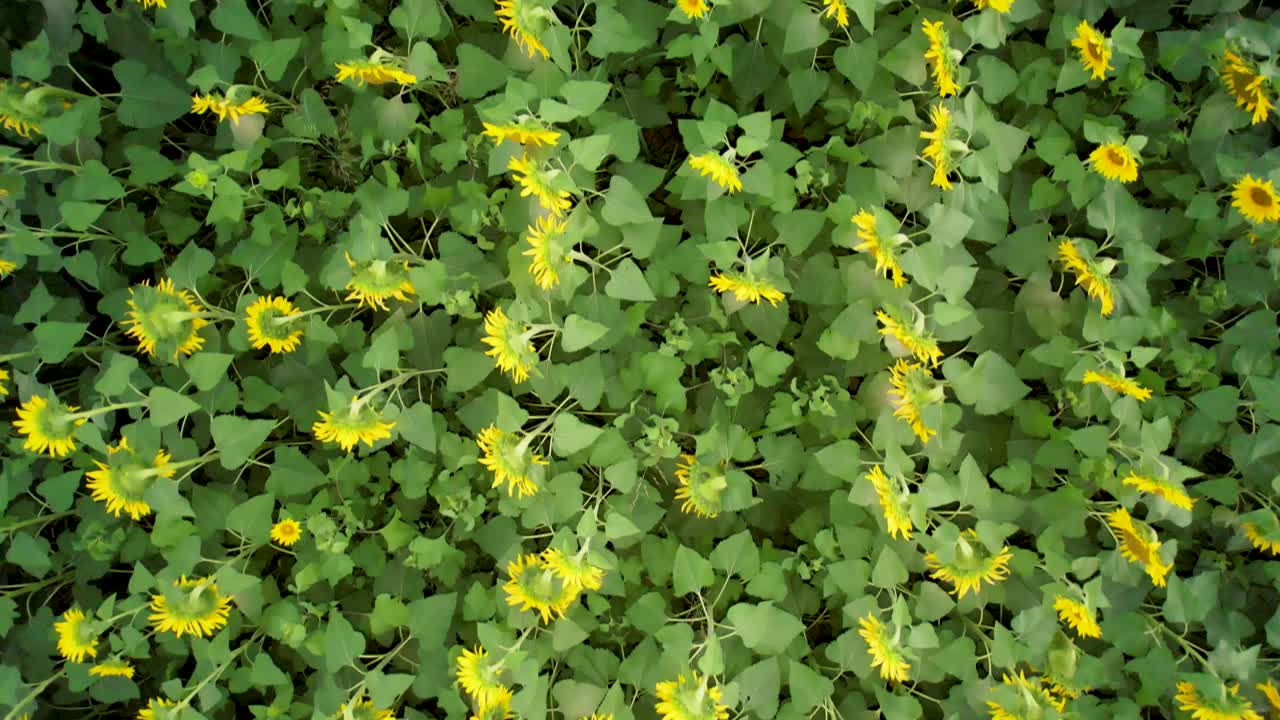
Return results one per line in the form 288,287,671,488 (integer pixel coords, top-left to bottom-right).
120,278,209,360
